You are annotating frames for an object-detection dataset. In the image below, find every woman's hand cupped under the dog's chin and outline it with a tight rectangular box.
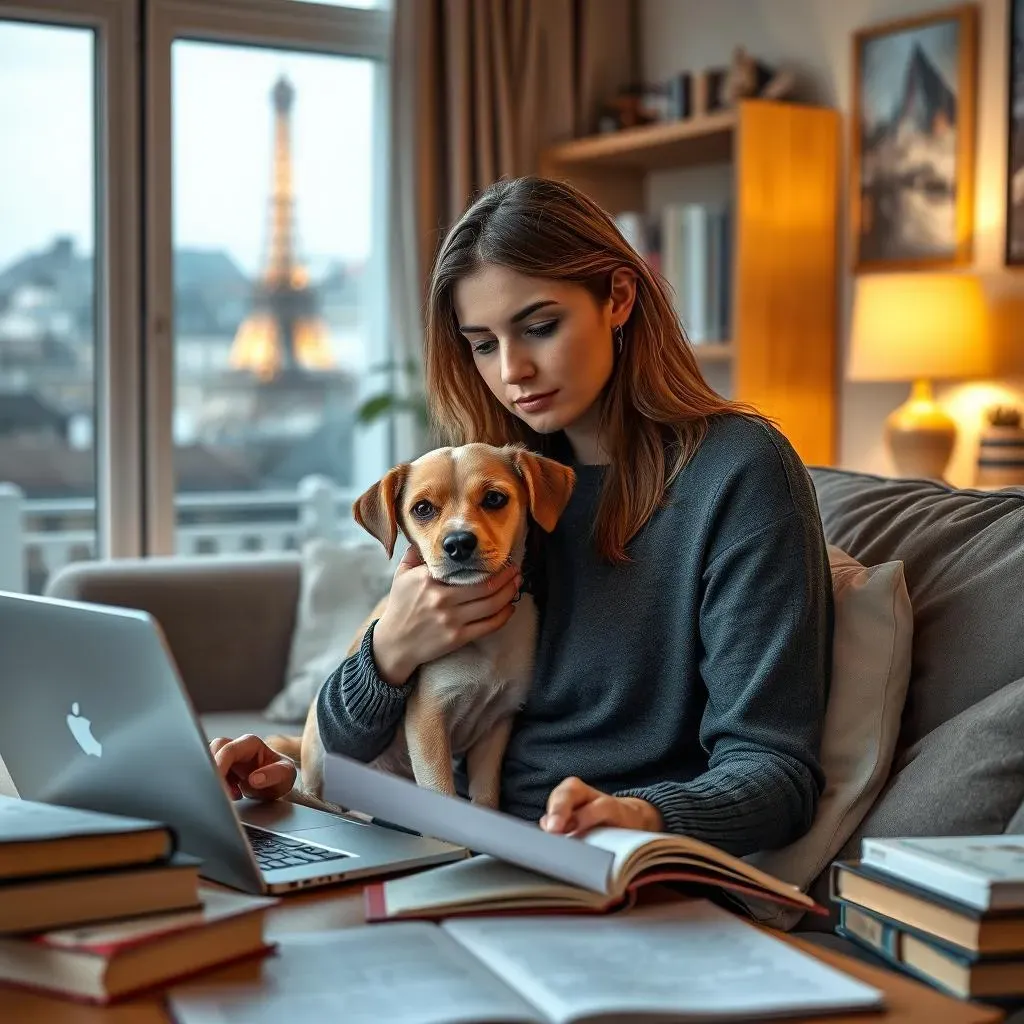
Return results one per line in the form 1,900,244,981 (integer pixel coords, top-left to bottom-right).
374,545,522,686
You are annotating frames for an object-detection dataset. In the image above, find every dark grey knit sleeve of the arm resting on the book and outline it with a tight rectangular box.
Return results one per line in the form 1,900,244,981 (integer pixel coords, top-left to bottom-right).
616,509,833,856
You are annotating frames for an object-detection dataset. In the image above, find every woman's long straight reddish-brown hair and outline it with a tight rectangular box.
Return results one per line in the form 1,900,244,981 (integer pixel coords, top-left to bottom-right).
425,177,757,562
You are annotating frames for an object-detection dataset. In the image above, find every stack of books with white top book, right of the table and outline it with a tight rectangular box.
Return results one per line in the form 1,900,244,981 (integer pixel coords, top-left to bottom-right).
830,836,1024,1000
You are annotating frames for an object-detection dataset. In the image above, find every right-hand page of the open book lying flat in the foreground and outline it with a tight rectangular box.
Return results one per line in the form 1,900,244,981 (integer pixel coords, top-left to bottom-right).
442,900,883,1024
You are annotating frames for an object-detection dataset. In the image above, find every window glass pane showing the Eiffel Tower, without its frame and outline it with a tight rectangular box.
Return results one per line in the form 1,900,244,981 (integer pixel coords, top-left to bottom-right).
171,40,380,554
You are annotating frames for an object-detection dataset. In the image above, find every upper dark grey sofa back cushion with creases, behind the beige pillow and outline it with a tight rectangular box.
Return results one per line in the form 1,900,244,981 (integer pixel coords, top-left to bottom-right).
811,468,1024,750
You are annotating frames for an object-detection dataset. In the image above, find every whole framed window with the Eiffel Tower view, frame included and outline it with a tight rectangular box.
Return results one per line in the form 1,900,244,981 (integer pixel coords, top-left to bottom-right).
144,0,390,555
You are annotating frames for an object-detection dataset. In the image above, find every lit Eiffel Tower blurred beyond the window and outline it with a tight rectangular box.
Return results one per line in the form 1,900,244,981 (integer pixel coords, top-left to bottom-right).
229,77,334,382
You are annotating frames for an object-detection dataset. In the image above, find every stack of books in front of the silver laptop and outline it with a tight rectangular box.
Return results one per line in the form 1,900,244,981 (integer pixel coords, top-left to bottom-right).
0,797,275,1002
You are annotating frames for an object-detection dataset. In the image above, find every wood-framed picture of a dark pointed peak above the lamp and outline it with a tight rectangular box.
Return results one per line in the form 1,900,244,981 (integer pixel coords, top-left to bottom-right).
850,0,974,270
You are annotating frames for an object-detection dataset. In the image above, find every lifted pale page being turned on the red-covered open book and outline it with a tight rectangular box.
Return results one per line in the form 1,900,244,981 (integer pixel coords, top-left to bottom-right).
324,754,612,893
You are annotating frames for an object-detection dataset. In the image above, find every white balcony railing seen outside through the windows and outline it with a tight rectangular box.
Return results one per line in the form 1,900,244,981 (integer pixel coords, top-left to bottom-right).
0,476,356,593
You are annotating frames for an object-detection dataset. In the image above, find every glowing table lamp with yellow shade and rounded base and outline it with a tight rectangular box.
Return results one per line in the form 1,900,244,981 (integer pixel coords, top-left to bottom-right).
848,273,992,479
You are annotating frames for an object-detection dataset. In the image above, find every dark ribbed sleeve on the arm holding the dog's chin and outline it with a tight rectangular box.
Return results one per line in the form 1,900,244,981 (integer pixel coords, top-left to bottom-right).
316,620,416,762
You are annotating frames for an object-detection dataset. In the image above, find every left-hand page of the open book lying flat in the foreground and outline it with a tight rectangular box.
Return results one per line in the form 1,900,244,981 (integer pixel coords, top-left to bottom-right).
168,923,546,1024
